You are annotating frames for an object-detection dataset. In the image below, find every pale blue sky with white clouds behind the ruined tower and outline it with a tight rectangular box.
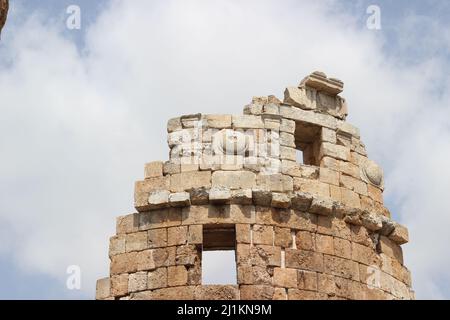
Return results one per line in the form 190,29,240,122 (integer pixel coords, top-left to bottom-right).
0,0,450,299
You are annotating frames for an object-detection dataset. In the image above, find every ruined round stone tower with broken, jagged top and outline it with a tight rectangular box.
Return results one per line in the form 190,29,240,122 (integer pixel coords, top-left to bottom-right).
96,72,414,300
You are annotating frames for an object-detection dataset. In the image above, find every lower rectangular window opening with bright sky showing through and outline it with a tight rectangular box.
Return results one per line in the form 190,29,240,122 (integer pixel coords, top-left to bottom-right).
202,225,237,285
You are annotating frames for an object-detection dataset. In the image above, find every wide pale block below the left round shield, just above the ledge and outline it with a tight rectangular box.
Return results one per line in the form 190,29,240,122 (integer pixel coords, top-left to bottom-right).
212,171,256,190
